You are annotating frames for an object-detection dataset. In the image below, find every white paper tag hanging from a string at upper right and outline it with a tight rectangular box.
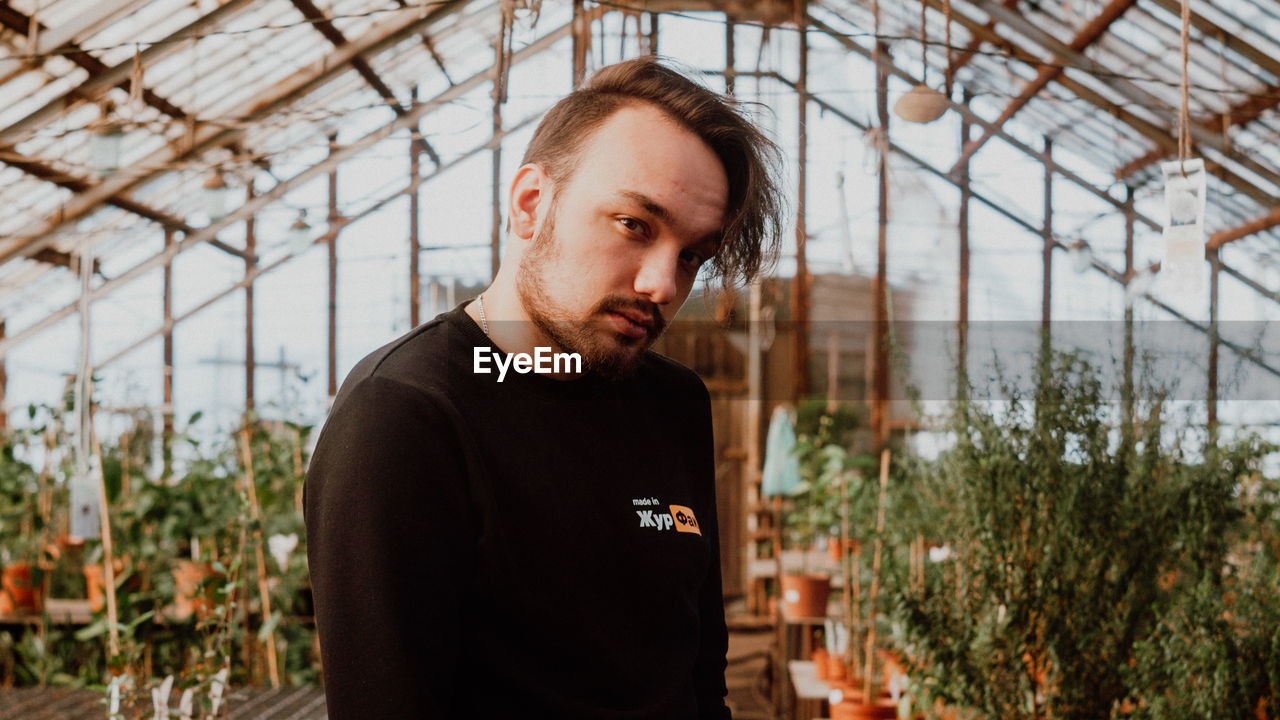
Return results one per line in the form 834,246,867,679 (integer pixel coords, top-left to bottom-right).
1160,158,1207,292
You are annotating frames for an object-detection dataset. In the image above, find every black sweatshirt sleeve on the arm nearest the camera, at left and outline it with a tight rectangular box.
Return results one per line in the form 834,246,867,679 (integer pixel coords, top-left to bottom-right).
305,375,474,720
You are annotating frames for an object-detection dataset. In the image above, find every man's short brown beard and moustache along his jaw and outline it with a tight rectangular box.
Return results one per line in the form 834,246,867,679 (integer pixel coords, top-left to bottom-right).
516,210,666,379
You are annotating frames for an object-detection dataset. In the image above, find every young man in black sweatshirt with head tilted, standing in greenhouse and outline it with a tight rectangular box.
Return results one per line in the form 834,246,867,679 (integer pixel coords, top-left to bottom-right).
306,59,780,720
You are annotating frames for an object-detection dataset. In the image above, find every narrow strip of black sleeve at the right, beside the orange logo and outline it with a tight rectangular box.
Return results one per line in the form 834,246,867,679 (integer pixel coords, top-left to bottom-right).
694,379,730,720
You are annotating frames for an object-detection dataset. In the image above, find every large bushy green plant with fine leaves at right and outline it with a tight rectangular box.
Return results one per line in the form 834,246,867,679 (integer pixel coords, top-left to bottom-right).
899,354,1276,720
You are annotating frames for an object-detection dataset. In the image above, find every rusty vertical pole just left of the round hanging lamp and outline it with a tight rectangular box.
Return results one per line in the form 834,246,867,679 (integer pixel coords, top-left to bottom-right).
872,42,890,451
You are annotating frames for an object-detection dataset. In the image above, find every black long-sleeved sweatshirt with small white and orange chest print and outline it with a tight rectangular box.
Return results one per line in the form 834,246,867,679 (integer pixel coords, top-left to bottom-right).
306,306,730,720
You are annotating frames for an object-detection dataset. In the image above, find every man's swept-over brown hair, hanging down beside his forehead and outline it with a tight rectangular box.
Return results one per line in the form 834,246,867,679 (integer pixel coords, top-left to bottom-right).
522,58,783,286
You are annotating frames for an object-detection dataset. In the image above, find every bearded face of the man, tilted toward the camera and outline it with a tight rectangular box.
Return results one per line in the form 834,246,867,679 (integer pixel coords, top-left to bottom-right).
516,104,728,377
